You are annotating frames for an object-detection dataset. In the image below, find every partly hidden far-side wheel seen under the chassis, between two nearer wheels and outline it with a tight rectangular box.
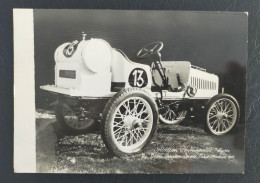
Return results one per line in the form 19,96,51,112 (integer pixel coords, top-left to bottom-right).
159,108,187,125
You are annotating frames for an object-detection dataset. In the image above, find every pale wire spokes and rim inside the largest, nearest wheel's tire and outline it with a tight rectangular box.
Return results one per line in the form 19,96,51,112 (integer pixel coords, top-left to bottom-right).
111,97,153,152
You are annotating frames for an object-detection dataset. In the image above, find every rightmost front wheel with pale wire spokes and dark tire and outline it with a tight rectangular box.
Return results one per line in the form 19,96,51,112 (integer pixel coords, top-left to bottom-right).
206,94,240,135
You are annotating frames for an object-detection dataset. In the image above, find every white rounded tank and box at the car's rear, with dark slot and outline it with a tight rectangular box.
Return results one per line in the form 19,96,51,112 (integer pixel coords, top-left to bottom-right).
54,39,112,96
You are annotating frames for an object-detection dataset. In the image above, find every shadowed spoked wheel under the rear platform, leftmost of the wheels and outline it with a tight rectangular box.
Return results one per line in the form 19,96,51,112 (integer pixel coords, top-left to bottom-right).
56,101,98,133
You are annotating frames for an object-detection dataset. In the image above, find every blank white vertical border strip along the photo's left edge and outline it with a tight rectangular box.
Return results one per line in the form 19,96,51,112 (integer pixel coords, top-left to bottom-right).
13,9,36,173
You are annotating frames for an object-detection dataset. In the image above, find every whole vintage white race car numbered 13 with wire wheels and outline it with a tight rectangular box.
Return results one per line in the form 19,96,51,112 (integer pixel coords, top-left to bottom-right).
41,33,240,156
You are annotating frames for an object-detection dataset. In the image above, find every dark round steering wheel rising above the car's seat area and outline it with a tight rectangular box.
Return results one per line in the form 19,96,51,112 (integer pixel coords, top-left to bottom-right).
136,41,163,58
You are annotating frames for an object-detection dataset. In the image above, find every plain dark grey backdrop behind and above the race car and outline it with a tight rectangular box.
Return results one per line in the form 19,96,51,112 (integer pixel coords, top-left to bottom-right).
34,10,247,123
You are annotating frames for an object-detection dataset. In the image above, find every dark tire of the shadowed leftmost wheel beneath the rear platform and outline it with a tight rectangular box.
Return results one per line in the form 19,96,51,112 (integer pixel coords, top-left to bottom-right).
55,101,99,134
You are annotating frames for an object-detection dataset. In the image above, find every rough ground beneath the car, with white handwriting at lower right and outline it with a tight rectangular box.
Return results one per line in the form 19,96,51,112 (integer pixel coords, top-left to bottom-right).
36,110,244,174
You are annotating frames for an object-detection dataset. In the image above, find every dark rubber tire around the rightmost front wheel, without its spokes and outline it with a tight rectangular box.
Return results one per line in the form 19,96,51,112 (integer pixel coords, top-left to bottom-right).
203,93,240,136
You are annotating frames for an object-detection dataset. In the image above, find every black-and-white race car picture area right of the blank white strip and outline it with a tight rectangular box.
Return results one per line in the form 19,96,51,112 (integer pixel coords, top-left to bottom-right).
14,9,248,174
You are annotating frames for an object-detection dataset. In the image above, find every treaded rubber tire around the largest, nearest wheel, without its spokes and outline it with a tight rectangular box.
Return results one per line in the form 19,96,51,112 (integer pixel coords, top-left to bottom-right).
100,88,159,157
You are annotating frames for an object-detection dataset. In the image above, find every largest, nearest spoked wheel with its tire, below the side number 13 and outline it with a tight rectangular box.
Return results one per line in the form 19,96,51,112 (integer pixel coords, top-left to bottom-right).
101,88,158,156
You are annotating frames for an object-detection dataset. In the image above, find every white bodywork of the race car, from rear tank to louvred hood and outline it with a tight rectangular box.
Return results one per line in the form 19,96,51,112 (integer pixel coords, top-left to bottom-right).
41,39,219,100
